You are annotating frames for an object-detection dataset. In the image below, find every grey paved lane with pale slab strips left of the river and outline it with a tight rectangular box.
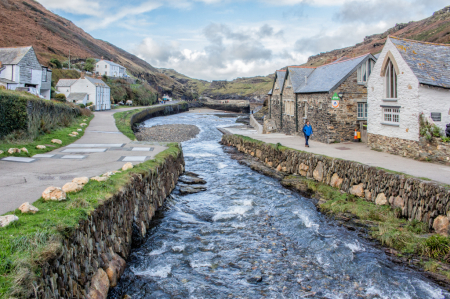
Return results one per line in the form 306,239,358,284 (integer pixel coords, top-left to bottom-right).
0,107,166,215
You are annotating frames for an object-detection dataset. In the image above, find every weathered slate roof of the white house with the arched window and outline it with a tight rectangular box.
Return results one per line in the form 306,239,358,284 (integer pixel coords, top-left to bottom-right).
389,36,450,88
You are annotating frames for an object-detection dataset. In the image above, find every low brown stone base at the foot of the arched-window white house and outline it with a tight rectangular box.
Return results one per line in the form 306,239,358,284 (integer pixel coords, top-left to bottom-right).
368,133,450,165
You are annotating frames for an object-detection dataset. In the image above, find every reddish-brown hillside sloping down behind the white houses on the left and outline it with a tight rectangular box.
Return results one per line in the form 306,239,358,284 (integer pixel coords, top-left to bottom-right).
0,0,192,98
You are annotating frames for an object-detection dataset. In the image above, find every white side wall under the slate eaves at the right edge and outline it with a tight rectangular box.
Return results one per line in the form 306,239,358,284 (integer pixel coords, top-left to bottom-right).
419,85,450,131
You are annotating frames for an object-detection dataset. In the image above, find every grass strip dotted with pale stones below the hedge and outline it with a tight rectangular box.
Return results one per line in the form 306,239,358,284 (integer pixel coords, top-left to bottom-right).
0,115,94,159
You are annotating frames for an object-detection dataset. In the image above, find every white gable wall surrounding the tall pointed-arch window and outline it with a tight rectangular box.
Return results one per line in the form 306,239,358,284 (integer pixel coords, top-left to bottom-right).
367,39,422,141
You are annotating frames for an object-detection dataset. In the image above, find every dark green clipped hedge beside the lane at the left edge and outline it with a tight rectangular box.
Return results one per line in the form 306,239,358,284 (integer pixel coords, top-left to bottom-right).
0,90,81,139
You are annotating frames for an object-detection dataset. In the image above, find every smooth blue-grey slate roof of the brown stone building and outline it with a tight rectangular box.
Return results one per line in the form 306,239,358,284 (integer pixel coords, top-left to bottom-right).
294,54,374,93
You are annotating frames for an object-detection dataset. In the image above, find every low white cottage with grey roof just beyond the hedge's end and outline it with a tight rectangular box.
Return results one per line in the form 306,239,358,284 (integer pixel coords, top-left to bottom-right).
56,74,111,111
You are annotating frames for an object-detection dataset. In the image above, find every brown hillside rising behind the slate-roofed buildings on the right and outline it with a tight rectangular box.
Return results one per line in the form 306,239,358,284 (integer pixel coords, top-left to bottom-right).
304,6,450,66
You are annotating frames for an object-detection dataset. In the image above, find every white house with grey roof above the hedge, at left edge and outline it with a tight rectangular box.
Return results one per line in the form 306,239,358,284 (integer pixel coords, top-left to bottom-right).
0,46,52,100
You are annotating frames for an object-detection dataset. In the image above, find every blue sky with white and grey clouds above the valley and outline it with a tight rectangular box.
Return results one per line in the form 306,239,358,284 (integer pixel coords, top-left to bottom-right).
38,0,448,80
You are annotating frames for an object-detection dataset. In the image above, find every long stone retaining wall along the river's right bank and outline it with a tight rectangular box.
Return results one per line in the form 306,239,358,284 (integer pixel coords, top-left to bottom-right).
222,135,450,228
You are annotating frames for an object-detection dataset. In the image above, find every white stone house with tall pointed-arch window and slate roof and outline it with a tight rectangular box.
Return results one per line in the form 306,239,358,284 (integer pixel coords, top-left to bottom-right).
368,36,450,153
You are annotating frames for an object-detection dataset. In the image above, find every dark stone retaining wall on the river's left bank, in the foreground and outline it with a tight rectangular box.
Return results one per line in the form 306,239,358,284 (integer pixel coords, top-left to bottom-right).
37,149,184,299
